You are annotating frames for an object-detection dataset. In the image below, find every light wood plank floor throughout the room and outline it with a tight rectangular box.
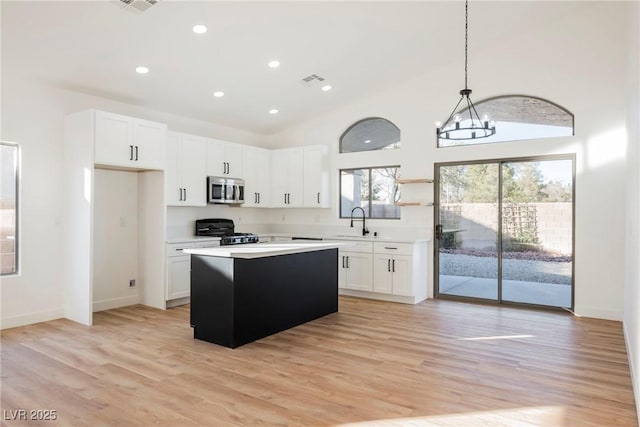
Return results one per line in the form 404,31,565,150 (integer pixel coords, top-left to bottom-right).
1,298,637,427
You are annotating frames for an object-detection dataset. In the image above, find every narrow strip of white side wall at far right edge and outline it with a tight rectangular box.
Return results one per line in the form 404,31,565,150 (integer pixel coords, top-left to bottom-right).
624,2,640,424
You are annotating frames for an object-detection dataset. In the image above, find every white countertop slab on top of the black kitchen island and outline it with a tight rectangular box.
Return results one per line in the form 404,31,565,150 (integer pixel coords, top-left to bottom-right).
184,242,342,258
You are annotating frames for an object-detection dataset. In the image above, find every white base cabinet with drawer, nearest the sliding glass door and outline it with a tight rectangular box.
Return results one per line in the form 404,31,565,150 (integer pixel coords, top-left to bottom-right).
373,242,413,296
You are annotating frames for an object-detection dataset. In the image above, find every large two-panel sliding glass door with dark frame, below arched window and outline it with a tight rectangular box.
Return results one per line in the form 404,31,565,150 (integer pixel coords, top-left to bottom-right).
435,156,574,308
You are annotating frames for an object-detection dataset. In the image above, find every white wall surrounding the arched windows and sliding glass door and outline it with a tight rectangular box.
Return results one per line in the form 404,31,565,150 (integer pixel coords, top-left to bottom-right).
271,3,628,320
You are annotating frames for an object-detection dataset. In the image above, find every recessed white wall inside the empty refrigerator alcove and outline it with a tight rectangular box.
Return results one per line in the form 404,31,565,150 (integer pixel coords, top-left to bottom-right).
93,169,140,311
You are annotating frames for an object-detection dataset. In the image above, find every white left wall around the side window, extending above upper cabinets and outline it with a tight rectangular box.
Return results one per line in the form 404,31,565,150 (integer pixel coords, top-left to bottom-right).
0,77,265,328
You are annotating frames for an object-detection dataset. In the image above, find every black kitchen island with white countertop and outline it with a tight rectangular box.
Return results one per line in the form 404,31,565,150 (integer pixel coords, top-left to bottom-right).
184,242,340,348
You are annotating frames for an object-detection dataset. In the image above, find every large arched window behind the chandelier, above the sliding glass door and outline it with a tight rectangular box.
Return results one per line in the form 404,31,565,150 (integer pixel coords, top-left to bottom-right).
438,95,574,147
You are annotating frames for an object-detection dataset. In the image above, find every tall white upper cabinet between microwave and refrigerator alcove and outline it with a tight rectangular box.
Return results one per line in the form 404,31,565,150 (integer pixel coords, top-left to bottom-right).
165,132,207,206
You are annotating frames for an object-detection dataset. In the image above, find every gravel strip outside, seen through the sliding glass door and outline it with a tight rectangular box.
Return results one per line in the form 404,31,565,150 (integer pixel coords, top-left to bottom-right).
440,253,571,285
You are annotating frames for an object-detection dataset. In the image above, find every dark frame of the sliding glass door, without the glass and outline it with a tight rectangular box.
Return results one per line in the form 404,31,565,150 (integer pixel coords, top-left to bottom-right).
433,153,576,312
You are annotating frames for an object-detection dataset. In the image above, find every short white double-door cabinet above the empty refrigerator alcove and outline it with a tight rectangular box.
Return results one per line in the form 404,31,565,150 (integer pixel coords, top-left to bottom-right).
94,110,167,170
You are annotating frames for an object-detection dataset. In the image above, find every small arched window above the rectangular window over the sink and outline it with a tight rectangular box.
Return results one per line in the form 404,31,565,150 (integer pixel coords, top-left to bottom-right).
340,117,400,153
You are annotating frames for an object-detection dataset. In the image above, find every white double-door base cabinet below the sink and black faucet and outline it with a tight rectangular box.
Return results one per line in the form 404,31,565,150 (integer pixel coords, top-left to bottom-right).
338,242,373,291
